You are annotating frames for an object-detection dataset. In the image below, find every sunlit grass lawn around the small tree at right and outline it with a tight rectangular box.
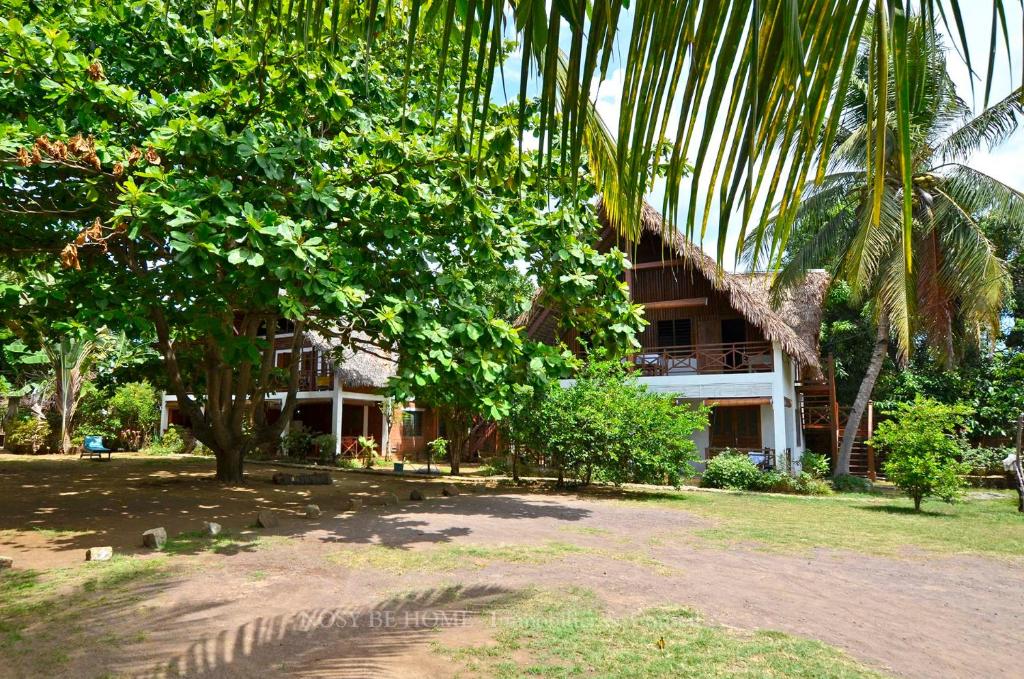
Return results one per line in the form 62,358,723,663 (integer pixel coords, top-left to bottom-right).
614,492,1024,557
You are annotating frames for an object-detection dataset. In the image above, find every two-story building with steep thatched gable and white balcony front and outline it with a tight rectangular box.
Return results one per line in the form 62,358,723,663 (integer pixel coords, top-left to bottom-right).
520,205,828,469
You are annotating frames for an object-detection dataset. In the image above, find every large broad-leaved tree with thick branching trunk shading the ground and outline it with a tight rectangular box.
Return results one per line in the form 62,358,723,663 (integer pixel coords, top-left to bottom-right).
0,0,638,482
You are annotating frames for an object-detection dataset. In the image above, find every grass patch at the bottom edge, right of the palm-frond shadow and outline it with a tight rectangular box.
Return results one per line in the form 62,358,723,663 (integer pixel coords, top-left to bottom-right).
434,589,883,679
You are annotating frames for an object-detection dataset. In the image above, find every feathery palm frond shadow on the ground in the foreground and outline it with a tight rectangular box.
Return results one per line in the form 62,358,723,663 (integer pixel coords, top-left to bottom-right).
131,585,523,679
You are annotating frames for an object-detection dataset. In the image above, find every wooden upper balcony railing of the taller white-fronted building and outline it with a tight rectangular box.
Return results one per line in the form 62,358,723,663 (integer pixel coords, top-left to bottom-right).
628,342,773,377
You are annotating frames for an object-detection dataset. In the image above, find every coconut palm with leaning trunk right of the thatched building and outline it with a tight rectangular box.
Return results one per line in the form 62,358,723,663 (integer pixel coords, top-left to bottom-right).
744,20,1024,474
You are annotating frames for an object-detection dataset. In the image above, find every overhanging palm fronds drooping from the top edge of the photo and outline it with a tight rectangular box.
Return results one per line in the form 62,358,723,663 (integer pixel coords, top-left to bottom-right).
234,0,1021,261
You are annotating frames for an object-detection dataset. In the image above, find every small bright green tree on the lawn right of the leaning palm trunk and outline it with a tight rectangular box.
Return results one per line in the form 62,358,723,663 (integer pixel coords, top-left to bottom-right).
870,396,971,511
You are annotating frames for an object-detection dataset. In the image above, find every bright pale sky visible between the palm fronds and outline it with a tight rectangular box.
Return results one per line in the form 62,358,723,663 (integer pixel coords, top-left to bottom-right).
505,5,1024,269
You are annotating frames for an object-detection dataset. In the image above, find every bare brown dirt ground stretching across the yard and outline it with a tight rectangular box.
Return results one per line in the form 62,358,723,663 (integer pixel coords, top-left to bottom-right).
0,456,1024,678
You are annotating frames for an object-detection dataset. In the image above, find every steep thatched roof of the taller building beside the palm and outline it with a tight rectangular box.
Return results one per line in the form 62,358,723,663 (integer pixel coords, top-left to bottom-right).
516,203,828,372
